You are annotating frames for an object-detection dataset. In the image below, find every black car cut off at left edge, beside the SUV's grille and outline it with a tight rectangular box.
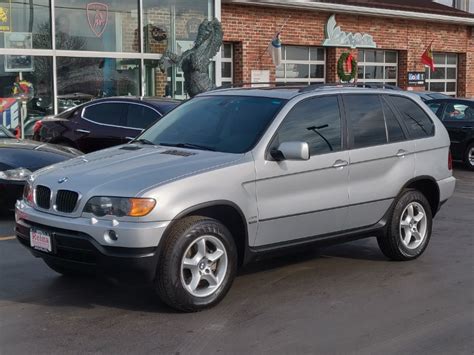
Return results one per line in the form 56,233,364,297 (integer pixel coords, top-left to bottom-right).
0,126,82,210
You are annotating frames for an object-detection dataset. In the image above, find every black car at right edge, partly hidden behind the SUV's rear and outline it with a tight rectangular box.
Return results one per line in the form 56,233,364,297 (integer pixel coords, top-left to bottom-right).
425,98,474,170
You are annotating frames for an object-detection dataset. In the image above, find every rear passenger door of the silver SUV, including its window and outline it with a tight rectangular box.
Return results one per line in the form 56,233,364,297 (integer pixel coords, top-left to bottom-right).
343,94,415,229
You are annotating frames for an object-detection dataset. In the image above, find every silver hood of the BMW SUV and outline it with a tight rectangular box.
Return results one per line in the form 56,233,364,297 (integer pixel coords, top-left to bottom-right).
33,144,244,197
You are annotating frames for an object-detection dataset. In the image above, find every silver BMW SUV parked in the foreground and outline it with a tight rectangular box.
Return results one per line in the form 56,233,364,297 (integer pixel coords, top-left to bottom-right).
16,87,455,311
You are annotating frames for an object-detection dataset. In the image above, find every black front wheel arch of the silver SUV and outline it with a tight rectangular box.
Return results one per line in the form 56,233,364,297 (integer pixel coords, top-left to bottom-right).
158,200,249,266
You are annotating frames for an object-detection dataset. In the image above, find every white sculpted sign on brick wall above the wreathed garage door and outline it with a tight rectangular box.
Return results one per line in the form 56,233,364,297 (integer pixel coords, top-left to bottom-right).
323,15,377,48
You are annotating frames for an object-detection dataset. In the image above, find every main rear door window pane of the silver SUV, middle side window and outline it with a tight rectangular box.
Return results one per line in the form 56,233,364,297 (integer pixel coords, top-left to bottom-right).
344,95,387,148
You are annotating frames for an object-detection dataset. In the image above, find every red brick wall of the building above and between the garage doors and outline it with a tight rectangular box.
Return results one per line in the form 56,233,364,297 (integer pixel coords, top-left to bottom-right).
222,4,474,97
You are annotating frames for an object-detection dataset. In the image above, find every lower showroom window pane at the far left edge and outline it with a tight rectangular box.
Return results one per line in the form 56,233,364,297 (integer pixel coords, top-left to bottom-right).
0,55,54,136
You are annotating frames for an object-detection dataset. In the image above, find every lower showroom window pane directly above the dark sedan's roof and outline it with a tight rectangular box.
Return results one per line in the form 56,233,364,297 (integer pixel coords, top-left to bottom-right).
57,57,140,112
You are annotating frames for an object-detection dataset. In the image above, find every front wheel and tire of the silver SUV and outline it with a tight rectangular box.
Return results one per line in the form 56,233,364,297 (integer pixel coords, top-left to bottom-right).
155,216,238,312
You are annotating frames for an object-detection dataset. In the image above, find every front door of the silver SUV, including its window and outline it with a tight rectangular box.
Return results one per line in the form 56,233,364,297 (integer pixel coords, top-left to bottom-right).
255,95,349,246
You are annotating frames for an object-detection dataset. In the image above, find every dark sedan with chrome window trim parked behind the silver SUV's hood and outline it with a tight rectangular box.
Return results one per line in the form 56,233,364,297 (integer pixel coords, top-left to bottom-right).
34,97,180,153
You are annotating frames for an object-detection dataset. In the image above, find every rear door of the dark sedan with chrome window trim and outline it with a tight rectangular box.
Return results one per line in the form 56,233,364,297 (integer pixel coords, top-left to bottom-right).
76,102,128,153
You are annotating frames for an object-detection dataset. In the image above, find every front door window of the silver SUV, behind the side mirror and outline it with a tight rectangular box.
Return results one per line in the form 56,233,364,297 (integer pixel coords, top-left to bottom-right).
272,96,342,155
